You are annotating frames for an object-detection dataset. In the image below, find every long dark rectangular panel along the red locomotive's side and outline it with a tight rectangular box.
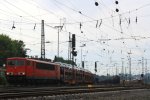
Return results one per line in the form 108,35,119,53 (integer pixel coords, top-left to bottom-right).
36,63,55,70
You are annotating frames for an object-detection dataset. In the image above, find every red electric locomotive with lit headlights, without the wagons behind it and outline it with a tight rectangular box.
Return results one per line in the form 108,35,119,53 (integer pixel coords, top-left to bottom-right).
6,57,60,84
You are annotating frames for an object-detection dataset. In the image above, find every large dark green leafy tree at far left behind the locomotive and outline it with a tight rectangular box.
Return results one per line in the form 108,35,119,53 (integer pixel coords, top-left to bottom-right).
0,34,26,66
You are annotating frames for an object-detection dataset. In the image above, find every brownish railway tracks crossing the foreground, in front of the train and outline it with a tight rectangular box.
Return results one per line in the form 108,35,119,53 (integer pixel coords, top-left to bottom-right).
0,86,147,99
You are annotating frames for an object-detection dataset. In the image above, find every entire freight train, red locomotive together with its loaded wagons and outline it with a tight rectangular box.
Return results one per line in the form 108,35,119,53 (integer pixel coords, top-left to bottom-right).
6,57,94,85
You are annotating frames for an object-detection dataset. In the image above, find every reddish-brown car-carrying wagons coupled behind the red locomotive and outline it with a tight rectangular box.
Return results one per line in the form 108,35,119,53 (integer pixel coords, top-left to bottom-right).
56,62,94,84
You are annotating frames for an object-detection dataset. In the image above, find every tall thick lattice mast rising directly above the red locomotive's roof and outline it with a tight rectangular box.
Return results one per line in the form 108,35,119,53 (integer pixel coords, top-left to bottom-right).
41,20,45,59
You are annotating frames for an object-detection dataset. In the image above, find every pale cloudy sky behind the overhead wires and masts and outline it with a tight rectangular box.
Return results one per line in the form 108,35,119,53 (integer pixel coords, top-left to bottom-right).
0,0,150,75
